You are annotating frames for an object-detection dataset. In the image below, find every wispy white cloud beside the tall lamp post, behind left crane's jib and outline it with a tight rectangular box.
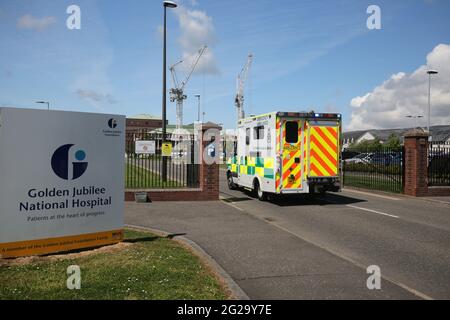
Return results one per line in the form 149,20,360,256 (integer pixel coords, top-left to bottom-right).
175,6,219,74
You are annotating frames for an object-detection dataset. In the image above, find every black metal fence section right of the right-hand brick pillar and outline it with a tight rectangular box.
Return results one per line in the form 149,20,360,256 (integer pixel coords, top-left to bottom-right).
428,142,450,186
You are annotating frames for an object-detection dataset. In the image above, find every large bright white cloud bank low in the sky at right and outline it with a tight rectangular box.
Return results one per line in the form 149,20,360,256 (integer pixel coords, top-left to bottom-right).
347,44,450,130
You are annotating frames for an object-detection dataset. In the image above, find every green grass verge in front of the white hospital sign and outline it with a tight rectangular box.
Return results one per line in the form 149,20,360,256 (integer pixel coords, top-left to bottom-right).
0,230,228,300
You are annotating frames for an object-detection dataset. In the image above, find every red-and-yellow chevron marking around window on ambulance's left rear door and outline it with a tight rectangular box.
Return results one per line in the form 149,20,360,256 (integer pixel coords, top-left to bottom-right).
281,122,303,189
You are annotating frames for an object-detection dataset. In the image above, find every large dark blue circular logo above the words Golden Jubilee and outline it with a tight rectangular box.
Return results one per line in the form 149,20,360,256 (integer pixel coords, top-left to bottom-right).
52,144,88,180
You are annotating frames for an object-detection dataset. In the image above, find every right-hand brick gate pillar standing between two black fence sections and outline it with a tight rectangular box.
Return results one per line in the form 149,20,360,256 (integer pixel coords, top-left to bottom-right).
404,130,428,197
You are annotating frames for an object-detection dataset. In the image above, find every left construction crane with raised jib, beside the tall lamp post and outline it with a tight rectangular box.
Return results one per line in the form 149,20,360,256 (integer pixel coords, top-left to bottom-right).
169,46,207,130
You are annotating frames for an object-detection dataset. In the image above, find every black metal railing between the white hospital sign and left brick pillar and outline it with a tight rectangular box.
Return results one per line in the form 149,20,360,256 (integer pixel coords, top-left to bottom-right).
125,131,200,189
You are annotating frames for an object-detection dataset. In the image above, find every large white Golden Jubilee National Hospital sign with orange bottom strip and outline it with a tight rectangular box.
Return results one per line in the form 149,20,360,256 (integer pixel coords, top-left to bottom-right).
0,108,125,257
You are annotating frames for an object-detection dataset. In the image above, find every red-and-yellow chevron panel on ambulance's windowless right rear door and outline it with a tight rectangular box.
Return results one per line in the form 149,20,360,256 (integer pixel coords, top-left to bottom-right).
309,127,339,177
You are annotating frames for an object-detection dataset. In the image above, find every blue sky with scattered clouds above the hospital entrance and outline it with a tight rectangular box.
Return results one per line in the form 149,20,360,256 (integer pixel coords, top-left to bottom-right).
0,0,450,131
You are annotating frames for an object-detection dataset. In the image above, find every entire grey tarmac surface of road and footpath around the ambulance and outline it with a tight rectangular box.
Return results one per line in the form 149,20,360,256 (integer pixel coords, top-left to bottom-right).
125,172,450,299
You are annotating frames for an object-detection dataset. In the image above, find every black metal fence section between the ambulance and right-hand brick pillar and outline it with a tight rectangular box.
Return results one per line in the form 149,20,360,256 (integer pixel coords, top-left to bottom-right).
342,147,404,193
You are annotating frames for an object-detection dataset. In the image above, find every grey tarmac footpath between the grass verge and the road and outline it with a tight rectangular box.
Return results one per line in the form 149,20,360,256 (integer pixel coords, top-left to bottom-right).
125,198,418,299
